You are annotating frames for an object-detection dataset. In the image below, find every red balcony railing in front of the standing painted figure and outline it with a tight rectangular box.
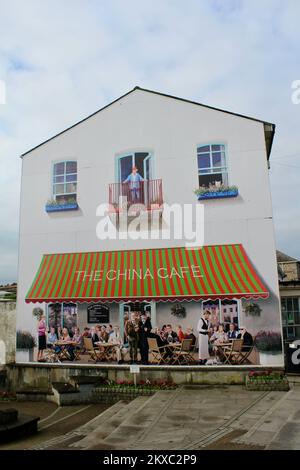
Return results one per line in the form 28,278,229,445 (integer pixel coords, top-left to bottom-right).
109,179,163,212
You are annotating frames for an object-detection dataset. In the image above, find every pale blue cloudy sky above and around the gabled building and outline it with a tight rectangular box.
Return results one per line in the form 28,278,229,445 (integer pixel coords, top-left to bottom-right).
0,0,300,283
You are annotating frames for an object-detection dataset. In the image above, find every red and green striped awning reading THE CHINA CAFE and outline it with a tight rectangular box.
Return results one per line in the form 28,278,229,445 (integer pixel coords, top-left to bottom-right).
26,244,269,302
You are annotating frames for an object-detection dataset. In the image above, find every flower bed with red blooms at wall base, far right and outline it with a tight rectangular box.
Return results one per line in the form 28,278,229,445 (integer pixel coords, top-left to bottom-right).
246,370,290,391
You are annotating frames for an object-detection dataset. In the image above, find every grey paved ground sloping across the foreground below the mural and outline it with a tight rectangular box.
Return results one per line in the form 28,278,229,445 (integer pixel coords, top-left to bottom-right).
2,383,300,450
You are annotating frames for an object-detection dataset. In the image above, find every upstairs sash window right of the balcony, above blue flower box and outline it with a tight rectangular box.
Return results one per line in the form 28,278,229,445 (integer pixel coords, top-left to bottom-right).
197,144,228,188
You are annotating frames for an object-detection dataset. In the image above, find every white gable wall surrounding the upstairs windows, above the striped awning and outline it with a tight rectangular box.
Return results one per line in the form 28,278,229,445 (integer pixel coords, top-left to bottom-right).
18,90,280,344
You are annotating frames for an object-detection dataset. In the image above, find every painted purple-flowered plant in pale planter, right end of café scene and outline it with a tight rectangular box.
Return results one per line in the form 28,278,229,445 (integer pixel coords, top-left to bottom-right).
255,331,283,366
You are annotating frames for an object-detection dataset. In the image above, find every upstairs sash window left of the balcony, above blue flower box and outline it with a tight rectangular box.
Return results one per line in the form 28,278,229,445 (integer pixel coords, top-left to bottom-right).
53,161,77,203
